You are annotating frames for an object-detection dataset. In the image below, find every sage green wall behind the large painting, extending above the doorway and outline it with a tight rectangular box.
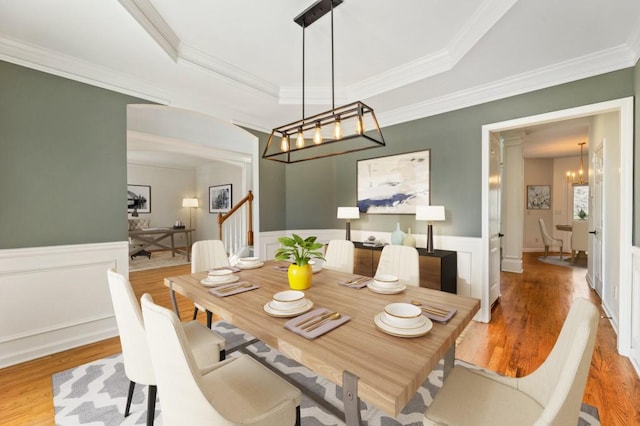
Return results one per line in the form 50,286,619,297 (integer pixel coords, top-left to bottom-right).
260,67,640,237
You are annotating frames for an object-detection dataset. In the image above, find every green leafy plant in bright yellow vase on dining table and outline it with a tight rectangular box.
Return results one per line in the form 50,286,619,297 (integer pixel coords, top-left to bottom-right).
275,234,324,290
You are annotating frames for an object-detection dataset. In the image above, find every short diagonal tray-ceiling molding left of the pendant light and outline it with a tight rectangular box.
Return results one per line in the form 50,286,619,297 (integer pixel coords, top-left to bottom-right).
118,0,180,62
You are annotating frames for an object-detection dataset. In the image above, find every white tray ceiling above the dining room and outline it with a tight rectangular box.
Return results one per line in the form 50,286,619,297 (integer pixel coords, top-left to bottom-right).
0,0,640,161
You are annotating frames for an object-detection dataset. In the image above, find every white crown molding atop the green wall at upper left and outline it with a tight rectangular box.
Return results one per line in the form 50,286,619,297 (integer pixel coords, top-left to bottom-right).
0,37,170,105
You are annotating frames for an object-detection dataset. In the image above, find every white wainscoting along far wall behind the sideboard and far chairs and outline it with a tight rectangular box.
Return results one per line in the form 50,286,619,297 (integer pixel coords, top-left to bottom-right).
259,229,484,322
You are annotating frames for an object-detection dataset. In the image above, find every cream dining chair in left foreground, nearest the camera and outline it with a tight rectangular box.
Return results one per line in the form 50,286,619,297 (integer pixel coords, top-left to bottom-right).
141,294,301,426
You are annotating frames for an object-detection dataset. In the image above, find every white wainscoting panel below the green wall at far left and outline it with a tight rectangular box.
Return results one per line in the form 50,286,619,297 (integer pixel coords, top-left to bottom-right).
0,241,129,368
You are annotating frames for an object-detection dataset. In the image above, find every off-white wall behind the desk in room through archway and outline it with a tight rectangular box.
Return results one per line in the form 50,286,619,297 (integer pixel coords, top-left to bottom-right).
127,163,196,246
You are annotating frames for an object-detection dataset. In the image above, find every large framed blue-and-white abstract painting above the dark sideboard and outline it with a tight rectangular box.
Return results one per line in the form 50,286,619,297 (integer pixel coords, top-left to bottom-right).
357,149,431,214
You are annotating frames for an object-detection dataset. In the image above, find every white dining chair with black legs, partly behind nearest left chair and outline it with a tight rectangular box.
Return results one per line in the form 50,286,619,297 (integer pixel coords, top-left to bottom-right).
107,269,225,425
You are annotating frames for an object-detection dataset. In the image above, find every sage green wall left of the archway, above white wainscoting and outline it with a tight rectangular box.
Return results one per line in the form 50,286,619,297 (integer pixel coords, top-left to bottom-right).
0,61,146,249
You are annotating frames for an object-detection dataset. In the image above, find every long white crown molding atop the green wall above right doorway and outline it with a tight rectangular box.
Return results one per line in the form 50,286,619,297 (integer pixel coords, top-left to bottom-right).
377,44,638,127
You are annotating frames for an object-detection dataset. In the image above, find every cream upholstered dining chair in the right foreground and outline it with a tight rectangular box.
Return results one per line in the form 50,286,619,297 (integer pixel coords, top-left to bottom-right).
424,298,600,426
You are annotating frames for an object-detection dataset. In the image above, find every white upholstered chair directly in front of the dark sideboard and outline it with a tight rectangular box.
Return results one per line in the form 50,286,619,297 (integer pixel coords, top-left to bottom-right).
376,245,420,286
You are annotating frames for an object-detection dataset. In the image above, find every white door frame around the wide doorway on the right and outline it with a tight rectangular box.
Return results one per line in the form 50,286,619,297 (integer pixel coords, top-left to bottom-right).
481,98,633,355
